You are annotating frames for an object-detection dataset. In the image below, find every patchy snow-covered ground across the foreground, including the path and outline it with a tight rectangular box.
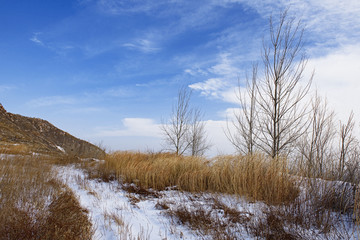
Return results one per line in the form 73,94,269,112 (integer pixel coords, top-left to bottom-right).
55,166,358,240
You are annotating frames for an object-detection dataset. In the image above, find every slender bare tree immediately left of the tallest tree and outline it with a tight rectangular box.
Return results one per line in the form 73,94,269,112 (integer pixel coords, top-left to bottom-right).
225,64,258,154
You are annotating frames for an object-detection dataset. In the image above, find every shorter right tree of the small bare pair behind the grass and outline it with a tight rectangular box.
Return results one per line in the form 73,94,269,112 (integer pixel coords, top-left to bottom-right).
188,108,211,156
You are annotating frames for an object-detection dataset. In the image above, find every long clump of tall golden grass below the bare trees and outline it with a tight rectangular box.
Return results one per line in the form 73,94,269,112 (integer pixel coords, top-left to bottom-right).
101,152,299,204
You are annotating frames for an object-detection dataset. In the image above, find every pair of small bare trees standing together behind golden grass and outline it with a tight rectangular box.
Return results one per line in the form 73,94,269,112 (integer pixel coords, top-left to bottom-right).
160,86,210,156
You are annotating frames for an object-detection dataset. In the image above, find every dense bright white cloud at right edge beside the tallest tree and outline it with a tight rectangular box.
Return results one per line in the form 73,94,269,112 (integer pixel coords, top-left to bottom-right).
308,44,360,122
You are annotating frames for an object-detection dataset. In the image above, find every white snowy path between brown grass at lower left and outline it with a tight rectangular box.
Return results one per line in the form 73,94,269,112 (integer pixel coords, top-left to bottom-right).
56,166,198,240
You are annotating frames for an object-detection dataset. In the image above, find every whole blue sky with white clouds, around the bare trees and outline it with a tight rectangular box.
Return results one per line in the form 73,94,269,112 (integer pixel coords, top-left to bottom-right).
0,0,360,154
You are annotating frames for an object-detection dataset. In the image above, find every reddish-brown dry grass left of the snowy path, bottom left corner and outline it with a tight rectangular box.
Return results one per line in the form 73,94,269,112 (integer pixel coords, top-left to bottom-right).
0,155,92,239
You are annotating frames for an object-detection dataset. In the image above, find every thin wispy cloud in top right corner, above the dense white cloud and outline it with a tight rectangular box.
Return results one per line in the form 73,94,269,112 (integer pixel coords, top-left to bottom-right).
228,0,360,54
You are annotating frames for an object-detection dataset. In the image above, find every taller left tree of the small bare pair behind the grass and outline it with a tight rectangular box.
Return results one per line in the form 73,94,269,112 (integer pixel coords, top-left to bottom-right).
160,86,192,155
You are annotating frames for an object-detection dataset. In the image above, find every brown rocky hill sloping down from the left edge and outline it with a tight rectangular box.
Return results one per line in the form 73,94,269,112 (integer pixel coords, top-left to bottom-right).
0,103,105,158
